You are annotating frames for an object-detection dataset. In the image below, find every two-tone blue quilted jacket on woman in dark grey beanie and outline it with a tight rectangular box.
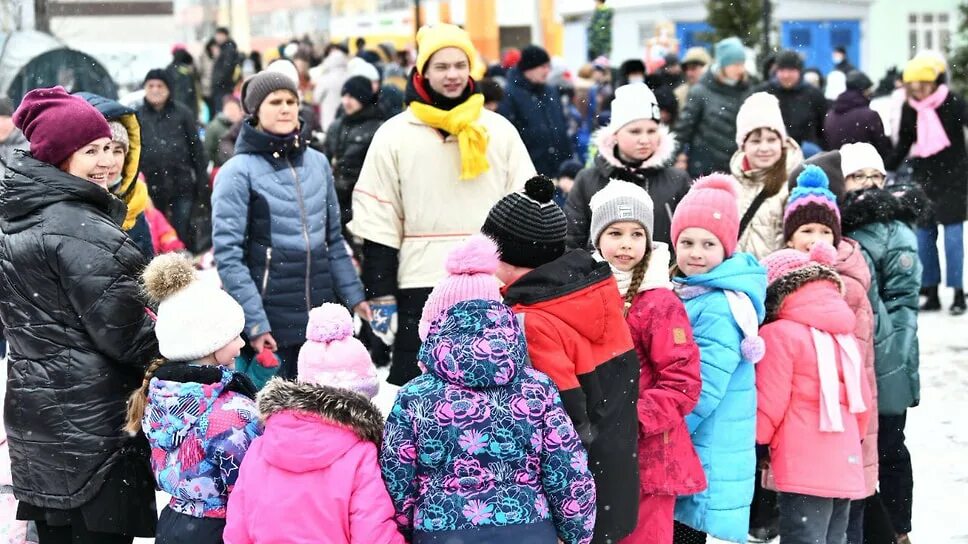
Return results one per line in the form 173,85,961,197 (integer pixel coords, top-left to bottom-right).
212,122,364,346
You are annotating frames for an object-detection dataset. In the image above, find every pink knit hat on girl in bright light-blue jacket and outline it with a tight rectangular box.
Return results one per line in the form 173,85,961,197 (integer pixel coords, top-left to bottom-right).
672,174,739,257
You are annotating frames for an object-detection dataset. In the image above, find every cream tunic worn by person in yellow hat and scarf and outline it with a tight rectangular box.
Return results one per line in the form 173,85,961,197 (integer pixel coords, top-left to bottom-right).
349,109,535,289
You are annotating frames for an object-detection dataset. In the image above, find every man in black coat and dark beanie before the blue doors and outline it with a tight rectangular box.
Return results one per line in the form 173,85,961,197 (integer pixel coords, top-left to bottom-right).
753,50,827,151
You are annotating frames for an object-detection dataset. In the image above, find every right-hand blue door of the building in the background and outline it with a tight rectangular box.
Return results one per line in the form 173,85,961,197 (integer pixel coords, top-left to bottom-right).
780,19,861,74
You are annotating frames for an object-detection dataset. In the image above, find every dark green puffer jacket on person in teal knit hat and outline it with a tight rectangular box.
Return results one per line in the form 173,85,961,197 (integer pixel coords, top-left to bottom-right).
673,71,751,178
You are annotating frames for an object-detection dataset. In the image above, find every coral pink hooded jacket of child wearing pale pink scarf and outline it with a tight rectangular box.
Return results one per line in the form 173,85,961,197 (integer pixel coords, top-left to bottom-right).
756,280,872,499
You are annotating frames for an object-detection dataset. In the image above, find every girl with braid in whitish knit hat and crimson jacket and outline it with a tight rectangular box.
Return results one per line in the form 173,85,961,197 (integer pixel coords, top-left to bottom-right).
591,180,706,544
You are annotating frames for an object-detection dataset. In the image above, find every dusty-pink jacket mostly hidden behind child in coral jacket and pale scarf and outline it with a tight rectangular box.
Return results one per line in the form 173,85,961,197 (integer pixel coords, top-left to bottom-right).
837,238,878,497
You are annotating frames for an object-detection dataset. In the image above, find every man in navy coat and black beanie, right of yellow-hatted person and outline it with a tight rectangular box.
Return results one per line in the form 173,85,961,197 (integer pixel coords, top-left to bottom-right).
498,45,574,177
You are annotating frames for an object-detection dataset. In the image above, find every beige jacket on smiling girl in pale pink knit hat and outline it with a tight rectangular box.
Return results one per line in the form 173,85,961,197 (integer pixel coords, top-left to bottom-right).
729,138,803,259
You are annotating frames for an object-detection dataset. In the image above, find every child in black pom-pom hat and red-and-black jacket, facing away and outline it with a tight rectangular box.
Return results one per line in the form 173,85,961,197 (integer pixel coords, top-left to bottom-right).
481,176,639,542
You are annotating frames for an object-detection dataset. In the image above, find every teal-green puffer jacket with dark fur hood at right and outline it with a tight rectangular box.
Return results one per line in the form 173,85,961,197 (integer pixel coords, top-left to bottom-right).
841,187,926,415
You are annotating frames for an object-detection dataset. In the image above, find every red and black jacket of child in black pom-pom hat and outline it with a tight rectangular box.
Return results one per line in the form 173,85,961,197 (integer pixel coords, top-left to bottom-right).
503,250,639,542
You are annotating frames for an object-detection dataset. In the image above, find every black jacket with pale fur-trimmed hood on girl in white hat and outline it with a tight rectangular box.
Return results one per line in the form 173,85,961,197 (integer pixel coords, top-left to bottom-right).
565,126,692,249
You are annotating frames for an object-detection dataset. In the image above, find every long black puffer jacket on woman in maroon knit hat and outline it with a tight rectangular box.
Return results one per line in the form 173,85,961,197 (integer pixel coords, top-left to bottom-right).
0,154,158,509
